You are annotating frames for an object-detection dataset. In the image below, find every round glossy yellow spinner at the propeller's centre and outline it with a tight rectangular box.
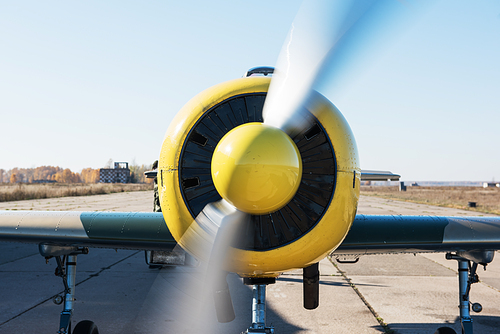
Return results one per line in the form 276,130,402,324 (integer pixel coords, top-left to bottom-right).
212,123,302,215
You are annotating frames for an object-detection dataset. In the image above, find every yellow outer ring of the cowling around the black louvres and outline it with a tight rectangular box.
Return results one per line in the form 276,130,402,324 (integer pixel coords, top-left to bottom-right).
158,77,360,277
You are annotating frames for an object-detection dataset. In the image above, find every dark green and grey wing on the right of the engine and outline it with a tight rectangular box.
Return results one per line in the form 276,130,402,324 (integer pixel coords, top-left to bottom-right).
333,215,500,256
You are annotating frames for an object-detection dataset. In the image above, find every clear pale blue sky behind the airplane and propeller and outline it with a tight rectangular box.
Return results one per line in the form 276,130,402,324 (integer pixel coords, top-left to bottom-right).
0,0,500,181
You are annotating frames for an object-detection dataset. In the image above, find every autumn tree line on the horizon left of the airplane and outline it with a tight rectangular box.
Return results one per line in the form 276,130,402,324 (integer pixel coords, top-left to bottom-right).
0,165,152,183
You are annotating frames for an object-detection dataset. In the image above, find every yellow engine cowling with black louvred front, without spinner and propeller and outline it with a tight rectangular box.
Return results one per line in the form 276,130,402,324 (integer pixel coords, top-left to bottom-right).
158,77,360,277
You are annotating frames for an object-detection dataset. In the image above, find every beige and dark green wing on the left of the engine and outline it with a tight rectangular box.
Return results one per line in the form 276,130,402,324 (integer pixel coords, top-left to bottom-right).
0,211,176,250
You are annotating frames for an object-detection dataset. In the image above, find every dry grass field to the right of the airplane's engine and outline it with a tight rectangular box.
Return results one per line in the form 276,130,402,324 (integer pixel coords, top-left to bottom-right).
361,186,500,215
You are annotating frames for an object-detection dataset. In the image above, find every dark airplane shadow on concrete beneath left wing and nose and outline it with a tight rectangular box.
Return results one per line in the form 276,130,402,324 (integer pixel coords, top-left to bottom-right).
0,243,307,334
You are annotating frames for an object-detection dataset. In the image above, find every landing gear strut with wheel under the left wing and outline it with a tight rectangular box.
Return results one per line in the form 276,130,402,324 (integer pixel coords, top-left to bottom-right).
38,244,99,334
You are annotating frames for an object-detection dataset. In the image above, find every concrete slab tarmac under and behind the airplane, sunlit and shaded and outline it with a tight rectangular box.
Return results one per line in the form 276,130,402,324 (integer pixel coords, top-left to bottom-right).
0,191,500,334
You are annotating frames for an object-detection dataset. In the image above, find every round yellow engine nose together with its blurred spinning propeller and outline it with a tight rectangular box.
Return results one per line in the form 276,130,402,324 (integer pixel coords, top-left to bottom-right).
153,0,426,328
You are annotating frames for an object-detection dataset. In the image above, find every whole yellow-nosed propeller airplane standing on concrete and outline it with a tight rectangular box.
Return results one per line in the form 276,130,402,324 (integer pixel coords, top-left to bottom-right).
0,1,500,334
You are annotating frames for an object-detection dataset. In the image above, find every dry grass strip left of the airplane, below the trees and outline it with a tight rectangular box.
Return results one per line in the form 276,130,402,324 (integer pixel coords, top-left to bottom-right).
0,183,153,202
